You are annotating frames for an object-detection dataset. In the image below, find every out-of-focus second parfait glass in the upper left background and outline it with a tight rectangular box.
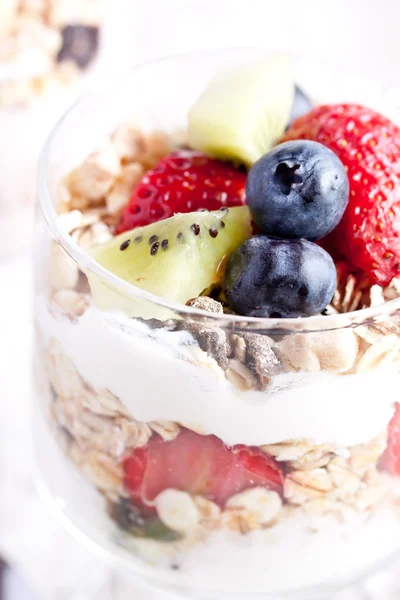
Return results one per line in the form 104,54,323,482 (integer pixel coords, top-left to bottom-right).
0,0,102,256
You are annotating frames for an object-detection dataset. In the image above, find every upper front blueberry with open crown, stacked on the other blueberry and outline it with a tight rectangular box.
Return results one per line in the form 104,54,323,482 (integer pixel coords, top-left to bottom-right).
246,140,349,240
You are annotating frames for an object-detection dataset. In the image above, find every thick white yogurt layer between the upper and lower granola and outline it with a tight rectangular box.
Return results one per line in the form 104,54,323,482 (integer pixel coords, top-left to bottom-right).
37,300,400,447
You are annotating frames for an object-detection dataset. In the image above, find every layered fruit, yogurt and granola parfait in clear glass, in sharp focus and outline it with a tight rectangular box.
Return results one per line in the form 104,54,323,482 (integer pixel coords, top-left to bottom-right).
36,56,400,598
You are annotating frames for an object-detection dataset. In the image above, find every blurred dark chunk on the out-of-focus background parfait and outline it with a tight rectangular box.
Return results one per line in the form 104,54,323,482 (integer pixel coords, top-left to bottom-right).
57,25,99,69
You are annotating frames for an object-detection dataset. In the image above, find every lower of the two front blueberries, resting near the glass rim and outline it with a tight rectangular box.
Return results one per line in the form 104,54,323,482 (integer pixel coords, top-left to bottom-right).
223,235,336,318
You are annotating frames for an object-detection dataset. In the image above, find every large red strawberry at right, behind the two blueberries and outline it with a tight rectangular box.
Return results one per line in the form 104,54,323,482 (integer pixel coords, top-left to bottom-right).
284,104,400,285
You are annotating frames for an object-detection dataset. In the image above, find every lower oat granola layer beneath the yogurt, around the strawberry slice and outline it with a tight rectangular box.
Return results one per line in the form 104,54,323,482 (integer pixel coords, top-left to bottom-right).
47,332,396,539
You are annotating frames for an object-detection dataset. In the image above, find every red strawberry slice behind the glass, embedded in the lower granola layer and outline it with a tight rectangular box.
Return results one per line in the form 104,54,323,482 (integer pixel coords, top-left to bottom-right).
123,429,283,507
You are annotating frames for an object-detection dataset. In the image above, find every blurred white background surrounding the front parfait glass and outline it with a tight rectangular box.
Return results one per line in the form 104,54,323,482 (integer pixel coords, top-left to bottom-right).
0,0,400,600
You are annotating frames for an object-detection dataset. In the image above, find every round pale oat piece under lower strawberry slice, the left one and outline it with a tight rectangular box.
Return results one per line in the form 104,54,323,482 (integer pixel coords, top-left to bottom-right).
155,489,200,532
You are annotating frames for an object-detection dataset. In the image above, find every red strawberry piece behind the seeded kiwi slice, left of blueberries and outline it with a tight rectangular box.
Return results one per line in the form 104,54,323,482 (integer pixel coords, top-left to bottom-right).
116,150,246,233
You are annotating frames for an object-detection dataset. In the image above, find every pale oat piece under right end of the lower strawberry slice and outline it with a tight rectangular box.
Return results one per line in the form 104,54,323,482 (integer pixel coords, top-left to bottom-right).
225,487,282,530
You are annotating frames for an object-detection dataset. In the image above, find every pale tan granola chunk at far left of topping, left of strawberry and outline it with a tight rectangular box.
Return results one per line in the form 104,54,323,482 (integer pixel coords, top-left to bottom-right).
66,144,121,200
